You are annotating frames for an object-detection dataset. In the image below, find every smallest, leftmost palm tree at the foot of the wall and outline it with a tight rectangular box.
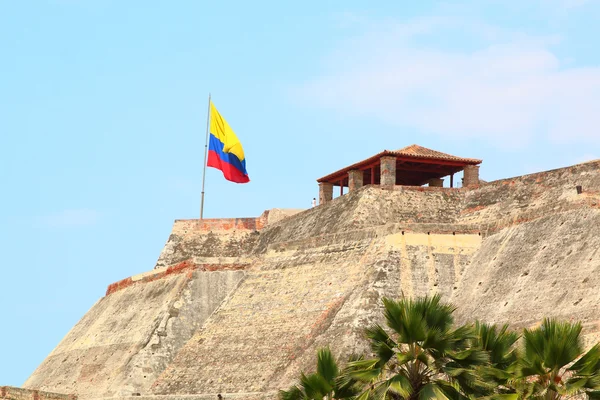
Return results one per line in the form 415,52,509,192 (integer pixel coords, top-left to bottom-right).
279,348,360,400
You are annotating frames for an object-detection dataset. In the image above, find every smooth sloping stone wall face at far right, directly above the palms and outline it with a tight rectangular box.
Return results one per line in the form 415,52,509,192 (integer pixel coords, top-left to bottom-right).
452,209,600,340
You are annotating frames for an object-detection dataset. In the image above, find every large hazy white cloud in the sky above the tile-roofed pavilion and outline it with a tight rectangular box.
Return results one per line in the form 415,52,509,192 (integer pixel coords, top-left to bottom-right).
293,14,600,147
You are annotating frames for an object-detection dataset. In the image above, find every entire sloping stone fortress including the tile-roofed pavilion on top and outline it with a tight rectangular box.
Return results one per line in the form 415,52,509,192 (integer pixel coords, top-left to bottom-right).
0,145,600,400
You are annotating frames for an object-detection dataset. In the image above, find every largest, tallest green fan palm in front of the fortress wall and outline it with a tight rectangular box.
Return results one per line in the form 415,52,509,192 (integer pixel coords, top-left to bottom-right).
345,295,489,400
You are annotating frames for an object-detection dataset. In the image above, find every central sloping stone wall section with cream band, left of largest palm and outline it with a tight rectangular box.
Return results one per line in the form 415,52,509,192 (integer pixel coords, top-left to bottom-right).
153,220,481,395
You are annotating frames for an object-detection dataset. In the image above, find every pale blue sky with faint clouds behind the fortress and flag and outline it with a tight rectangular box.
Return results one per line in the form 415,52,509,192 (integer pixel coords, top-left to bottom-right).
0,0,600,386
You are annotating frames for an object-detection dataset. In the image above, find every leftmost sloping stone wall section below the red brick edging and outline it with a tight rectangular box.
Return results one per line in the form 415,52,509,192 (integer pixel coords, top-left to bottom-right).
24,270,244,398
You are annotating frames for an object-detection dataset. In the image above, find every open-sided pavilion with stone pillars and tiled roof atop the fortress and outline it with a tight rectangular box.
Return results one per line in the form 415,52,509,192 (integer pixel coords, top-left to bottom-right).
317,144,482,204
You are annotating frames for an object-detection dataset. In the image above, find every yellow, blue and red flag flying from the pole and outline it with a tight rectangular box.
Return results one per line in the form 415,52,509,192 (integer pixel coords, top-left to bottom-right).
207,101,250,183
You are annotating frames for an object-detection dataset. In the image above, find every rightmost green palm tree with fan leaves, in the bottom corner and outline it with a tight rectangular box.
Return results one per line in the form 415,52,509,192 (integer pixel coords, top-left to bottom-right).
512,319,600,400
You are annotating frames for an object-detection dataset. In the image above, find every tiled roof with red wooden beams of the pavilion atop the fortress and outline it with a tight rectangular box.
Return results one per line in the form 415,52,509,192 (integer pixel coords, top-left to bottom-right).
317,144,482,185
